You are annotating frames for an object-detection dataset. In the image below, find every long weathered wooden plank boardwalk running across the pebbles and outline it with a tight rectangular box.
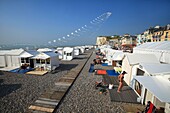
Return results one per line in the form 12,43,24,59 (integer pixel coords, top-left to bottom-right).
28,53,92,113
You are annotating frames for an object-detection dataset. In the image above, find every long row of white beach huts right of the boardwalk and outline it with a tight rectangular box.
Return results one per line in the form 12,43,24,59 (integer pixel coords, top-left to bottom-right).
100,41,170,113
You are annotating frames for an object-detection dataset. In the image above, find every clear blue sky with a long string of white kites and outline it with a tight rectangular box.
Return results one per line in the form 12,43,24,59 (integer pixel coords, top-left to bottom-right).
0,0,170,46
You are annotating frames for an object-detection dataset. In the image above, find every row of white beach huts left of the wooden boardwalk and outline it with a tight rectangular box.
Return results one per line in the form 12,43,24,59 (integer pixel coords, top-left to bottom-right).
0,46,93,71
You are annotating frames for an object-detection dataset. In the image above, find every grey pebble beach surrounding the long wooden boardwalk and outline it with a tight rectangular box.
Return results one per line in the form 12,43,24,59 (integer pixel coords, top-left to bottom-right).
0,50,144,113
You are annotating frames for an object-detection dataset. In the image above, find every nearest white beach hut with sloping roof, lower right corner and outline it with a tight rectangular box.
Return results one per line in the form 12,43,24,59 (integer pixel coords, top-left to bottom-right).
134,76,170,113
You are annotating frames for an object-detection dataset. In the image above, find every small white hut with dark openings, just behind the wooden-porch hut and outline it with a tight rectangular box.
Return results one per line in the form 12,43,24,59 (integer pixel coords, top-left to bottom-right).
63,47,74,61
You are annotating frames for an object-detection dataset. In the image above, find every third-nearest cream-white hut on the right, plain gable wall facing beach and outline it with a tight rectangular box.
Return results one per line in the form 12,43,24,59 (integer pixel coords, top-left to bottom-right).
122,53,160,86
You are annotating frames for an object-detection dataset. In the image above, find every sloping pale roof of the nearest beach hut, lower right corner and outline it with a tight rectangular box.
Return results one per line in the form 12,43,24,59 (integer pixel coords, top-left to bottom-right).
134,76,170,103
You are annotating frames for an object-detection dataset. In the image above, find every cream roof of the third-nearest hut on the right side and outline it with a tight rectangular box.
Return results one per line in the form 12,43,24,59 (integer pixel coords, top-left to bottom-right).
126,53,160,65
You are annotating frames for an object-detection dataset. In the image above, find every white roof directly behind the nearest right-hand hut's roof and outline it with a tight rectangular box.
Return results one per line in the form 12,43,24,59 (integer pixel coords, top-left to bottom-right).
140,63,170,75
